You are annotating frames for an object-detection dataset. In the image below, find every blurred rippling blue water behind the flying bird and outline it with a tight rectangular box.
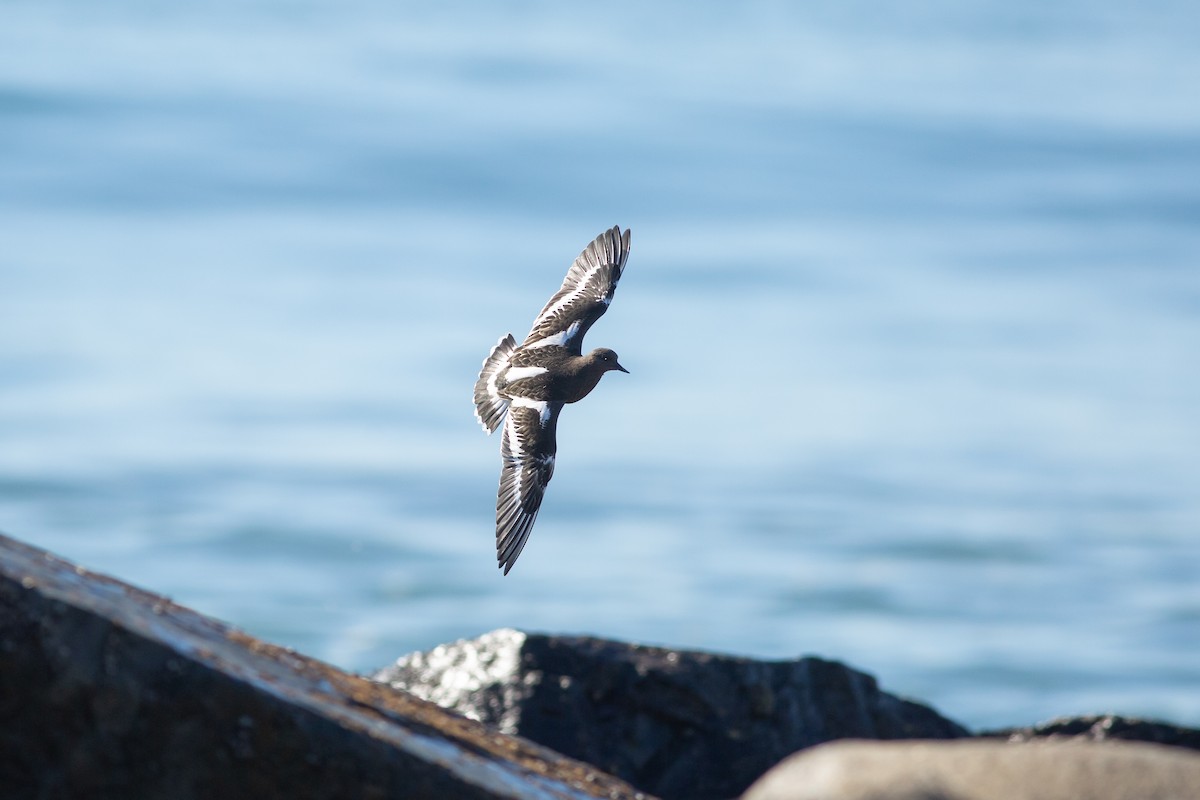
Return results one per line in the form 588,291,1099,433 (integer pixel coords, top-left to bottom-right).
0,0,1200,726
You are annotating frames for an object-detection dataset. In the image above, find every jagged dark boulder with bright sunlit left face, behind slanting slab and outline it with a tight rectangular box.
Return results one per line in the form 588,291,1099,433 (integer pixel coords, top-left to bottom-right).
374,630,968,800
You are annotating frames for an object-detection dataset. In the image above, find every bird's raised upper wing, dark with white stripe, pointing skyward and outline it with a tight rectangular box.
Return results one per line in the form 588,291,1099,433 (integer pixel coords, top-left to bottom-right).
521,227,630,355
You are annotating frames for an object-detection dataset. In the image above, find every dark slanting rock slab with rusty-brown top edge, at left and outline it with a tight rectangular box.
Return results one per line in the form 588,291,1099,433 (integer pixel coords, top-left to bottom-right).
0,536,646,800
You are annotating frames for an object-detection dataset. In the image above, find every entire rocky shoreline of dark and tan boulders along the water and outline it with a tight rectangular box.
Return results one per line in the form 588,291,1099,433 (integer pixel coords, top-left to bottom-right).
0,527,1200,800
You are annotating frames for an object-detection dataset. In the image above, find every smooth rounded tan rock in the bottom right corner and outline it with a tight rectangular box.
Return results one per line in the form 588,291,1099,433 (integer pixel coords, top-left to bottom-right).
742,740,1200,800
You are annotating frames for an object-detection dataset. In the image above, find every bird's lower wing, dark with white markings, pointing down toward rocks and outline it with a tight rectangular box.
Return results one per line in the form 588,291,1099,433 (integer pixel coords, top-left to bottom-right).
496,397,563,575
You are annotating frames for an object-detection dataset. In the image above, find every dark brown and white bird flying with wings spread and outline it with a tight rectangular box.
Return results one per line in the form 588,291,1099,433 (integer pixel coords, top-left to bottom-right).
475,227,629,575
